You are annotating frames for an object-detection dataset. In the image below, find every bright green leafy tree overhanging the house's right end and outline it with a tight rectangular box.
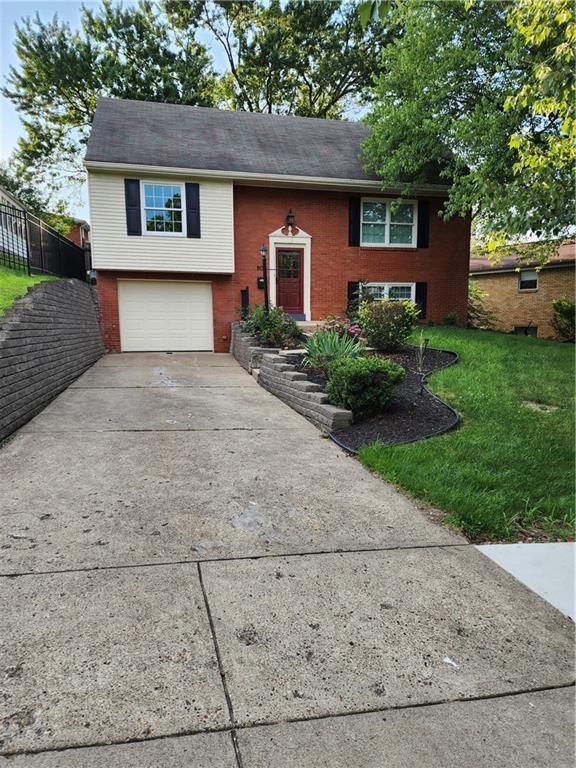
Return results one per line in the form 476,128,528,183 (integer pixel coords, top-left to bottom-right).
365,0,574,254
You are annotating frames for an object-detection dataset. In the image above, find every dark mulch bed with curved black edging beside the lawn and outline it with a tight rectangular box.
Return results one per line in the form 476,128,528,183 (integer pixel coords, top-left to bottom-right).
299,346,458,451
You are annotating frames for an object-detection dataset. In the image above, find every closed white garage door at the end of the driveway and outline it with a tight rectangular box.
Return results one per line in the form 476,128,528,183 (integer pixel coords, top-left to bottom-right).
118,280,214,352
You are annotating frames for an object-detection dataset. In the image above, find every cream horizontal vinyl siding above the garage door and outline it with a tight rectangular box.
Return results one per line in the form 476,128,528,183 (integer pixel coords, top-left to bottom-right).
88,169,234,274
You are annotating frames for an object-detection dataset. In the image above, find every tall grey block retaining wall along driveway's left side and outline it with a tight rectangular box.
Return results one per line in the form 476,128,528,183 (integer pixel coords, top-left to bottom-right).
0,280,104,440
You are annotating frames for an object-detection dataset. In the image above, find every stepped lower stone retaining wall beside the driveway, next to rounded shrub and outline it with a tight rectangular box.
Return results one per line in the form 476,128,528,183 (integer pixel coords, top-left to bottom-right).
258,354,352,433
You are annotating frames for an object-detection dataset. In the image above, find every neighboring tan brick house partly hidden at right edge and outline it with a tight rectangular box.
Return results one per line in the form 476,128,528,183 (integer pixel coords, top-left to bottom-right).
470,242,576,338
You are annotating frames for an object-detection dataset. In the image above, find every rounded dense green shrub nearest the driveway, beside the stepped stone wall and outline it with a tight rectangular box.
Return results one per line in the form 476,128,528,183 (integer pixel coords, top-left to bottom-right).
326,357,406,418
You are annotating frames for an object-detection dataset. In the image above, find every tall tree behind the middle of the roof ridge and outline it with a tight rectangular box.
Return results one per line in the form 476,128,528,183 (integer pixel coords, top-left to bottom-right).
164,0,387,118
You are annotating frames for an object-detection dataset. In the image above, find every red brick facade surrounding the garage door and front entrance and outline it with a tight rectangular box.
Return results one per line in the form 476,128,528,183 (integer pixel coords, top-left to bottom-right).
98,187,470,352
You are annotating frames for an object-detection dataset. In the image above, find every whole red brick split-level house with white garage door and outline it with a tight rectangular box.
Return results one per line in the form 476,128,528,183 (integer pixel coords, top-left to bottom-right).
85,99,470,352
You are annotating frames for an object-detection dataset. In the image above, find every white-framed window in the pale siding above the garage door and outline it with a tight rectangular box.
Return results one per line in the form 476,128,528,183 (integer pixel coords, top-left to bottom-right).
140,181,186,237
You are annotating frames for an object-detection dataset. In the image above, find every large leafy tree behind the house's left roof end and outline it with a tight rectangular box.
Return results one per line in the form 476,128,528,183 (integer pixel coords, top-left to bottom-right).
3,0,214,189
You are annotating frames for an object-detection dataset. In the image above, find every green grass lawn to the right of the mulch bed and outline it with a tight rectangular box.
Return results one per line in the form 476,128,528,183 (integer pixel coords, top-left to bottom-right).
360,327,574,541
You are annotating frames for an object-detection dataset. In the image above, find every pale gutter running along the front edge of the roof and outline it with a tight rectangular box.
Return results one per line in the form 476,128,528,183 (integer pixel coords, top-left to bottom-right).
84,160,448,196
